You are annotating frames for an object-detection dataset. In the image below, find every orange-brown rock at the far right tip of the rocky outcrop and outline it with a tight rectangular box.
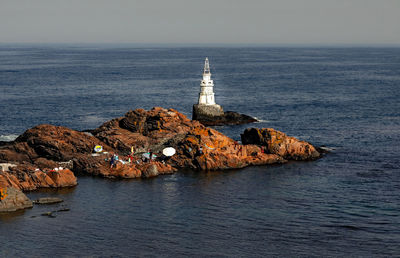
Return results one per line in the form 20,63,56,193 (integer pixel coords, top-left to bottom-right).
241,128,321,160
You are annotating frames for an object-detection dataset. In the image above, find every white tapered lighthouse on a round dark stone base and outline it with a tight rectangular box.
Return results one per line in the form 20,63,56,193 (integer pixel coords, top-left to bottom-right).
192,57,224,121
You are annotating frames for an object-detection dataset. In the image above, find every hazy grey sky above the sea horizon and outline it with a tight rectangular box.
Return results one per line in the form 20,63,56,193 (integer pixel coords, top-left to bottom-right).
0,0,400,45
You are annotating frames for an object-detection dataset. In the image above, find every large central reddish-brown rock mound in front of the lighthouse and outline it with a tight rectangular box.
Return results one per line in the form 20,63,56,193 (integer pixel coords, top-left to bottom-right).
92,108,285,172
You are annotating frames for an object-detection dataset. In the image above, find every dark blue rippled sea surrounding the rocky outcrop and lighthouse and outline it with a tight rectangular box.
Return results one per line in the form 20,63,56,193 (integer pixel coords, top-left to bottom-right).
0,45,400,257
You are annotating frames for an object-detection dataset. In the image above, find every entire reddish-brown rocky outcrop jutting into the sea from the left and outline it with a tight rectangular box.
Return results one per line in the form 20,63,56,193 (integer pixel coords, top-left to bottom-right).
0,107,321,211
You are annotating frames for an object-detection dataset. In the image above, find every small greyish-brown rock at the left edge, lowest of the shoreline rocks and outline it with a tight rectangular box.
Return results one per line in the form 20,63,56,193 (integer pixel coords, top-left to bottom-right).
0,187,33,212
